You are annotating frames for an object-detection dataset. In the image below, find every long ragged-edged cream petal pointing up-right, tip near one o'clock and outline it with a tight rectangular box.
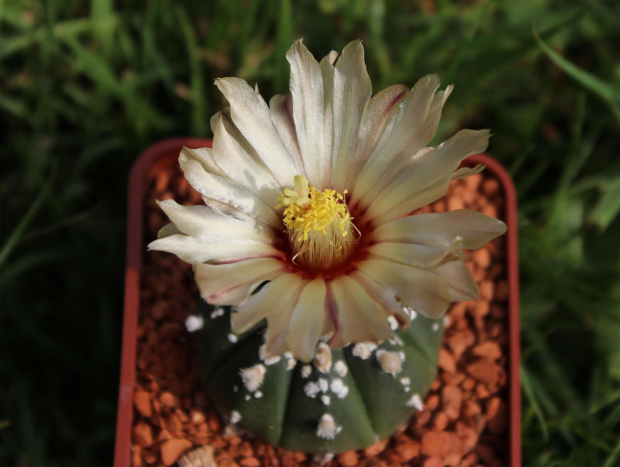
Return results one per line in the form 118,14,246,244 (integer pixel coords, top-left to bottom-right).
351,75,439,205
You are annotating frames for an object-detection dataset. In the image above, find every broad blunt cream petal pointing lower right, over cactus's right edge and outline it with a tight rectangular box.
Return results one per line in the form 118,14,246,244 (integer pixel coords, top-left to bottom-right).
358,259,450,318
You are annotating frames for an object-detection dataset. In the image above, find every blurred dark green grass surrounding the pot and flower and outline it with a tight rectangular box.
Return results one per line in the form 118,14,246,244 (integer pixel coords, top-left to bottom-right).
0,0,620,467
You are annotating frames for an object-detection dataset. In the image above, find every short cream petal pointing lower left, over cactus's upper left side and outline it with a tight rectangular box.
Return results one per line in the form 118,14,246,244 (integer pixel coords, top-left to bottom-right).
230,274,307,337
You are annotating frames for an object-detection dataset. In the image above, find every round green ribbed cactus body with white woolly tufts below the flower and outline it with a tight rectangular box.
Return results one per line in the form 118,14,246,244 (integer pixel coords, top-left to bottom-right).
195,302,443,454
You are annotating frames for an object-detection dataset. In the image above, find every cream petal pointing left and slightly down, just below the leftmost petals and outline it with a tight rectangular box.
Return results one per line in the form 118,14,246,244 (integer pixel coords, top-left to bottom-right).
194,258,286,305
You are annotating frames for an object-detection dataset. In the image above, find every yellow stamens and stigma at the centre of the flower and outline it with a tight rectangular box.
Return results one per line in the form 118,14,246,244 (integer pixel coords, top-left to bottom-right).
276,175,355,270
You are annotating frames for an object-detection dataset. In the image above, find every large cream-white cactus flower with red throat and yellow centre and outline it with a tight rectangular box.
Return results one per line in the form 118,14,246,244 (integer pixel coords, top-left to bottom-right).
149,41,506,362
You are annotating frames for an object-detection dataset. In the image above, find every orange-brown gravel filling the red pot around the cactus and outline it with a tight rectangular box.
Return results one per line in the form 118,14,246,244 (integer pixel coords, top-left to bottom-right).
131,166,508,467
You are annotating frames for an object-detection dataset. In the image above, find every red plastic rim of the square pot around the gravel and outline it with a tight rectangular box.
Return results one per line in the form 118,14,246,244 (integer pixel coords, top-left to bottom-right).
114,138,521,467
